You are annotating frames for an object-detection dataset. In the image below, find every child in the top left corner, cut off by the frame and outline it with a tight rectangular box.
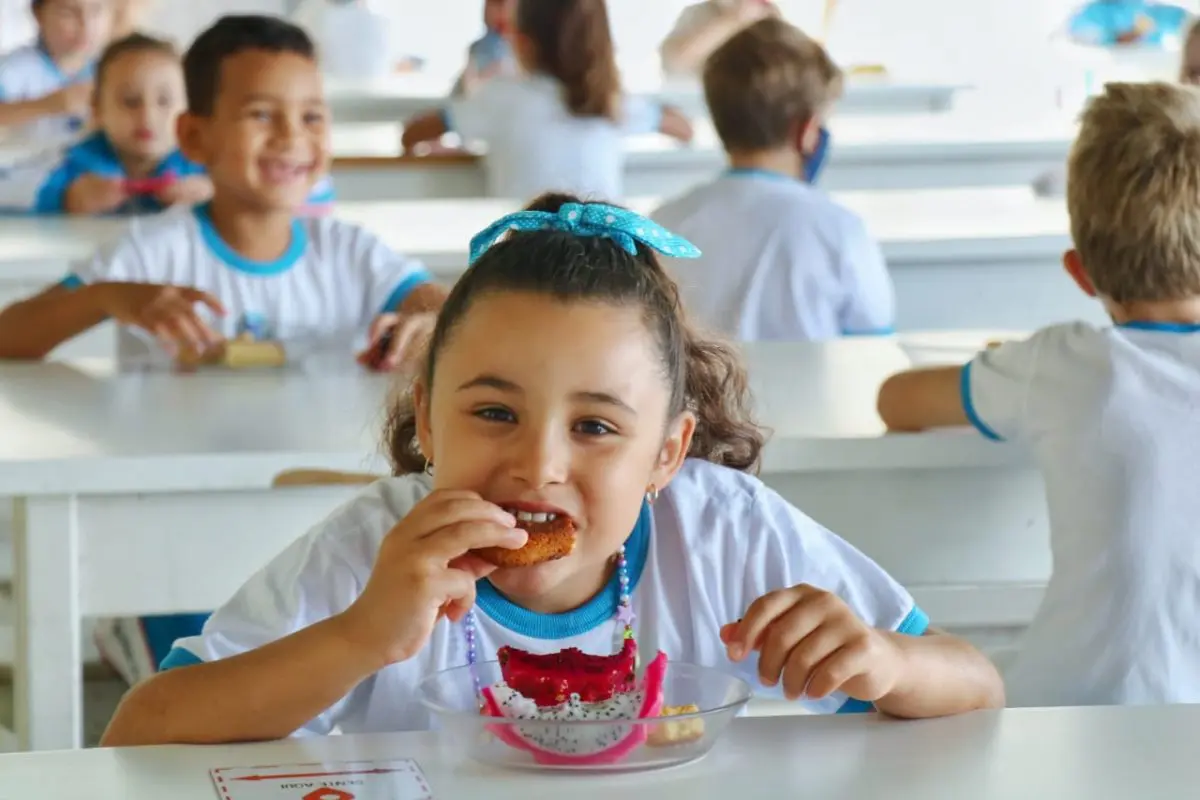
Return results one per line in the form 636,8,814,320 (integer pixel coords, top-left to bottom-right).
0,0,113,140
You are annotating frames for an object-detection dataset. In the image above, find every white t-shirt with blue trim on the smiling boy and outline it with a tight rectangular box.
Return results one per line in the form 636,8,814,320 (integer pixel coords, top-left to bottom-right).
64,204,433,366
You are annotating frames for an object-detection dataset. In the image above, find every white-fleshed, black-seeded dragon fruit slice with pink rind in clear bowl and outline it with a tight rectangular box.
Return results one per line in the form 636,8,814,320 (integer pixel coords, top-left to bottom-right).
482,639,667,766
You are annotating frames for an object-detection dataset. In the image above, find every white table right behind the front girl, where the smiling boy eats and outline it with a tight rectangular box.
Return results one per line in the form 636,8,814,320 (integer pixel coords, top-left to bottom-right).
0,332,1050,750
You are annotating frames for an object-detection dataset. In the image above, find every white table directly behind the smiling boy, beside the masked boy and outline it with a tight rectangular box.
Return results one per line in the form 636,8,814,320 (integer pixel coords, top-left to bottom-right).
0,187,1104,355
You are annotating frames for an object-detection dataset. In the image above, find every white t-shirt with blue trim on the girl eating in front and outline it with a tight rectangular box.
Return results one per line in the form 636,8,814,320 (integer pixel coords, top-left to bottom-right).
163,459,929,734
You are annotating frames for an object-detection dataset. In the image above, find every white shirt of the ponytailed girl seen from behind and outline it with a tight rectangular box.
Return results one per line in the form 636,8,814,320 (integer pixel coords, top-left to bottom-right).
443,74,662,201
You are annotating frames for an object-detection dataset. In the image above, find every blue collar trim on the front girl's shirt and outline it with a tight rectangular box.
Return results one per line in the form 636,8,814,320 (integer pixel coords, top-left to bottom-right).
475,501,653,640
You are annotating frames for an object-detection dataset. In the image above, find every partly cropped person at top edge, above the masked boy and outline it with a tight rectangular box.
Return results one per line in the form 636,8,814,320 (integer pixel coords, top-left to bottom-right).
659,0,779,76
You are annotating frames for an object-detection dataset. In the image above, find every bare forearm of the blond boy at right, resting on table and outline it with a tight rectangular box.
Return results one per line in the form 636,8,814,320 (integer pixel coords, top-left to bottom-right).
877,367,971,431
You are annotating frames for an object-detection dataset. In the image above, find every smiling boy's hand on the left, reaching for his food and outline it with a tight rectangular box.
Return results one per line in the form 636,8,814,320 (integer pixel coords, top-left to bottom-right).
98,283,226,356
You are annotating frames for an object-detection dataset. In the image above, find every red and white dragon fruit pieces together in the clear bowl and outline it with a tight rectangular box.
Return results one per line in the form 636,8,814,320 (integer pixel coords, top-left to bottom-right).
481,638,667,766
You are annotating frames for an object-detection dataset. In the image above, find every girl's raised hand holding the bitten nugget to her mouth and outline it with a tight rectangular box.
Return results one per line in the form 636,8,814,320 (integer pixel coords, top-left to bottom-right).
341,489,528,668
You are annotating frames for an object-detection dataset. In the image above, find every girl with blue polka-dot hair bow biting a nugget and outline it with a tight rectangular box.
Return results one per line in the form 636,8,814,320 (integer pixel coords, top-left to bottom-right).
104,196,1003,746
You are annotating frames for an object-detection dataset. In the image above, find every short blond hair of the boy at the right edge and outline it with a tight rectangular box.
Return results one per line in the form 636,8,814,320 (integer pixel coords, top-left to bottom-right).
1067,83,1200,303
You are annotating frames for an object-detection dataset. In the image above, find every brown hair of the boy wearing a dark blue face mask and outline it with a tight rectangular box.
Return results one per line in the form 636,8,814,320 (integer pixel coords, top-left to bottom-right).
704,18,842,152
